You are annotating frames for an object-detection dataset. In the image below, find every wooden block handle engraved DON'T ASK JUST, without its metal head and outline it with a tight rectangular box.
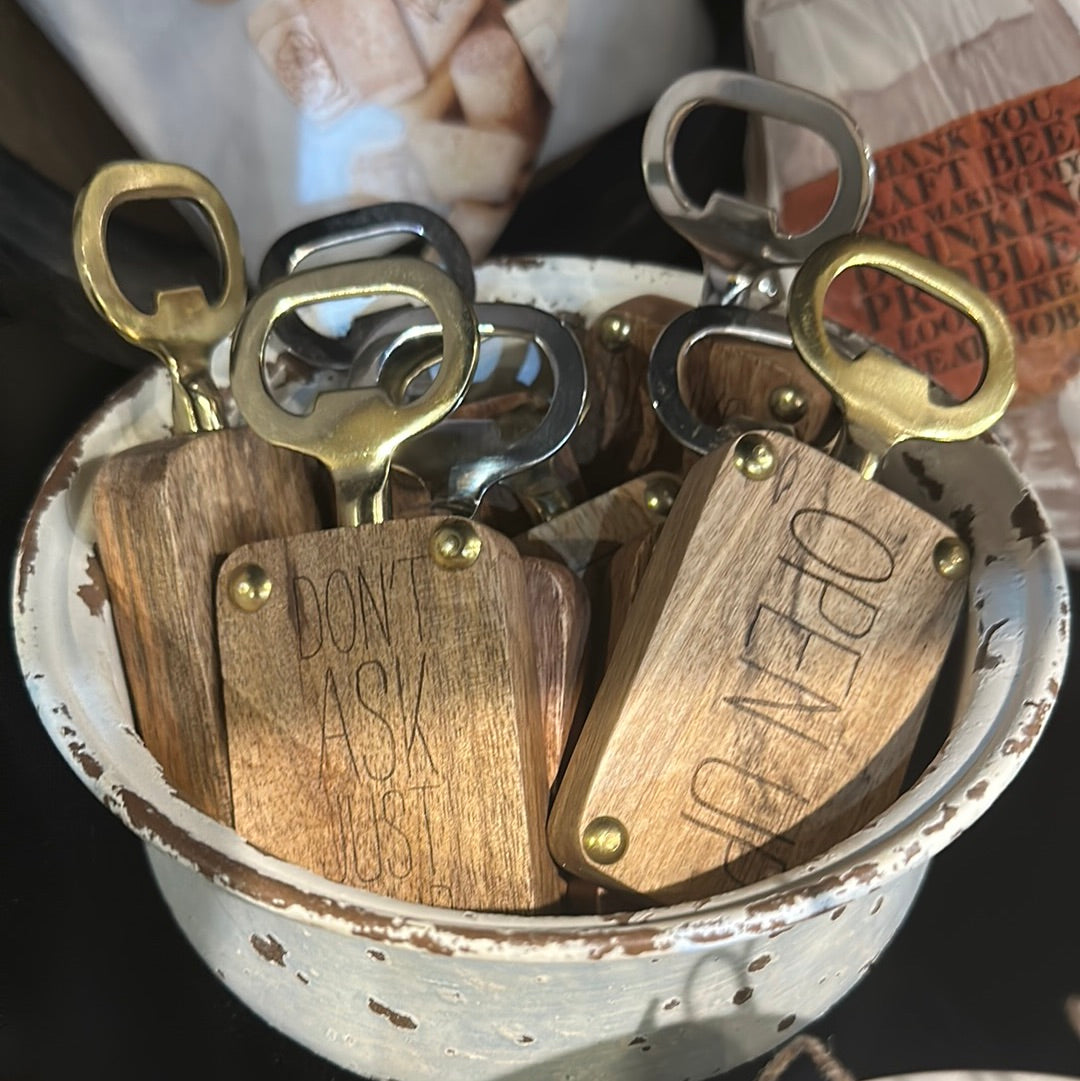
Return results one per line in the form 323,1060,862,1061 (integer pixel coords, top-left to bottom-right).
217,518,560,911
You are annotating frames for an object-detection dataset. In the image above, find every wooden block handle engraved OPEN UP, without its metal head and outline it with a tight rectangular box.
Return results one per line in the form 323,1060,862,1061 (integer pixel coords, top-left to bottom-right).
548,435,964,902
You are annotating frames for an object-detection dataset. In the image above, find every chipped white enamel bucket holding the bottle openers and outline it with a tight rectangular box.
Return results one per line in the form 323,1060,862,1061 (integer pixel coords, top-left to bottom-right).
14,258,1068,1081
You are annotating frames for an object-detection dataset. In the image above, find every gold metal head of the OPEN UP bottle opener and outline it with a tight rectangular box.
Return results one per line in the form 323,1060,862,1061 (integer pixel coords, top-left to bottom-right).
787,237,1016,479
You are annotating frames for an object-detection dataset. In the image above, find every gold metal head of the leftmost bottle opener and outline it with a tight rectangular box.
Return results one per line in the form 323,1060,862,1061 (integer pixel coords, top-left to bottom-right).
72,161,248,435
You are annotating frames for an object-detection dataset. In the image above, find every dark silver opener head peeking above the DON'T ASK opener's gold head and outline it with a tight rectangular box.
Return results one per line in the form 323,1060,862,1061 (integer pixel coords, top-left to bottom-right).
258,202,476,371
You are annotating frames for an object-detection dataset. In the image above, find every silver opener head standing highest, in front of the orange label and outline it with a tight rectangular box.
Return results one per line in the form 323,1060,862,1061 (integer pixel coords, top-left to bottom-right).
641,70,874,303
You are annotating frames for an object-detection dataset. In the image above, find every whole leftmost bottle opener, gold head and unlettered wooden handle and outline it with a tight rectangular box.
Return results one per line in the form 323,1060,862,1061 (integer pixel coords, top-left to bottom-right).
74,161,319,823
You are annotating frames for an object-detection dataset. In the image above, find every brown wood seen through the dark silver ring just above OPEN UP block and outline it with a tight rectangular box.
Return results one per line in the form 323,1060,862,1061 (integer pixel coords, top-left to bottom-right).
679,335,836,443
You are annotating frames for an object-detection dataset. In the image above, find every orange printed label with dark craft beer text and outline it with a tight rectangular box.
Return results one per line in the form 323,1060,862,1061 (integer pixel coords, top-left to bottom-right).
784,78,1080,399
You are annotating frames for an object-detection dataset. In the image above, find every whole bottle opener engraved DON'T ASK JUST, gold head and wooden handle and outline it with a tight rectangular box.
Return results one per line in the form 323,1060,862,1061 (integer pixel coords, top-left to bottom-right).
217,259,560,911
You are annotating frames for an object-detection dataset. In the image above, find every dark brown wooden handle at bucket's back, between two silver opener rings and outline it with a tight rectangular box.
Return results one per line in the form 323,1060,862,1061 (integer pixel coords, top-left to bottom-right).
569,296,688,495
